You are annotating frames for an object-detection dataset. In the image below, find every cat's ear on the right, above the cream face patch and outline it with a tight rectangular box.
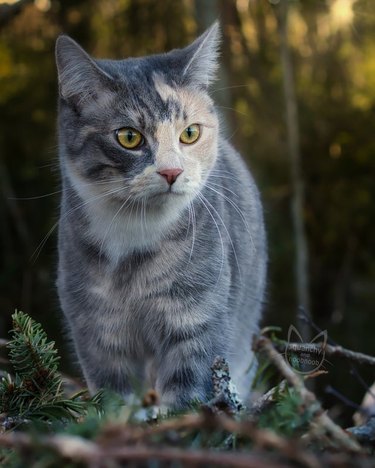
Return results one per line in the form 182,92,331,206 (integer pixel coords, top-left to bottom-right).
182,21,220,87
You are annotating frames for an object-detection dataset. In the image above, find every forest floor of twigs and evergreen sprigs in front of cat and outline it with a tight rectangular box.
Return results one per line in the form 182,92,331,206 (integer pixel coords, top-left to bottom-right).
0,312,375,468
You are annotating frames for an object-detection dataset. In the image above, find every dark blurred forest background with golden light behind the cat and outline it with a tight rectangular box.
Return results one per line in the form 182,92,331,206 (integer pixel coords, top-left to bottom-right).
0,0,375,424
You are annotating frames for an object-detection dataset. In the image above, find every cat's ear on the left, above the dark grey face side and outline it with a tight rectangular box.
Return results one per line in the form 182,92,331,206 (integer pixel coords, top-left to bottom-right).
56,35,112,104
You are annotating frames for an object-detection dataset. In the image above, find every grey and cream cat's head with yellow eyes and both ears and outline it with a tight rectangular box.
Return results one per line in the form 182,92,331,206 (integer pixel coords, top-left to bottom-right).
56,23,219,215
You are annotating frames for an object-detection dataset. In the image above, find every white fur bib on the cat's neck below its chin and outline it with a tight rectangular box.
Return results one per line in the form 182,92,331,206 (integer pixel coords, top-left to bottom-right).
64,175,188,265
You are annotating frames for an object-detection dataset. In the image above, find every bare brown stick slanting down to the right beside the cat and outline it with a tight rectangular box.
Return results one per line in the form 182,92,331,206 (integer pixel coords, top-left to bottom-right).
254,336,361,452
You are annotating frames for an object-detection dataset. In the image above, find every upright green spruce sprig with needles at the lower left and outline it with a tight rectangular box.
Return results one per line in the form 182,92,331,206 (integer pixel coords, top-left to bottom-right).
0,311,97,423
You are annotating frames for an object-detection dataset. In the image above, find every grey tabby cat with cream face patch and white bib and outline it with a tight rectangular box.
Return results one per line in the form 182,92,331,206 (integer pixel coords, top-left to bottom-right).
56,23,267,409
